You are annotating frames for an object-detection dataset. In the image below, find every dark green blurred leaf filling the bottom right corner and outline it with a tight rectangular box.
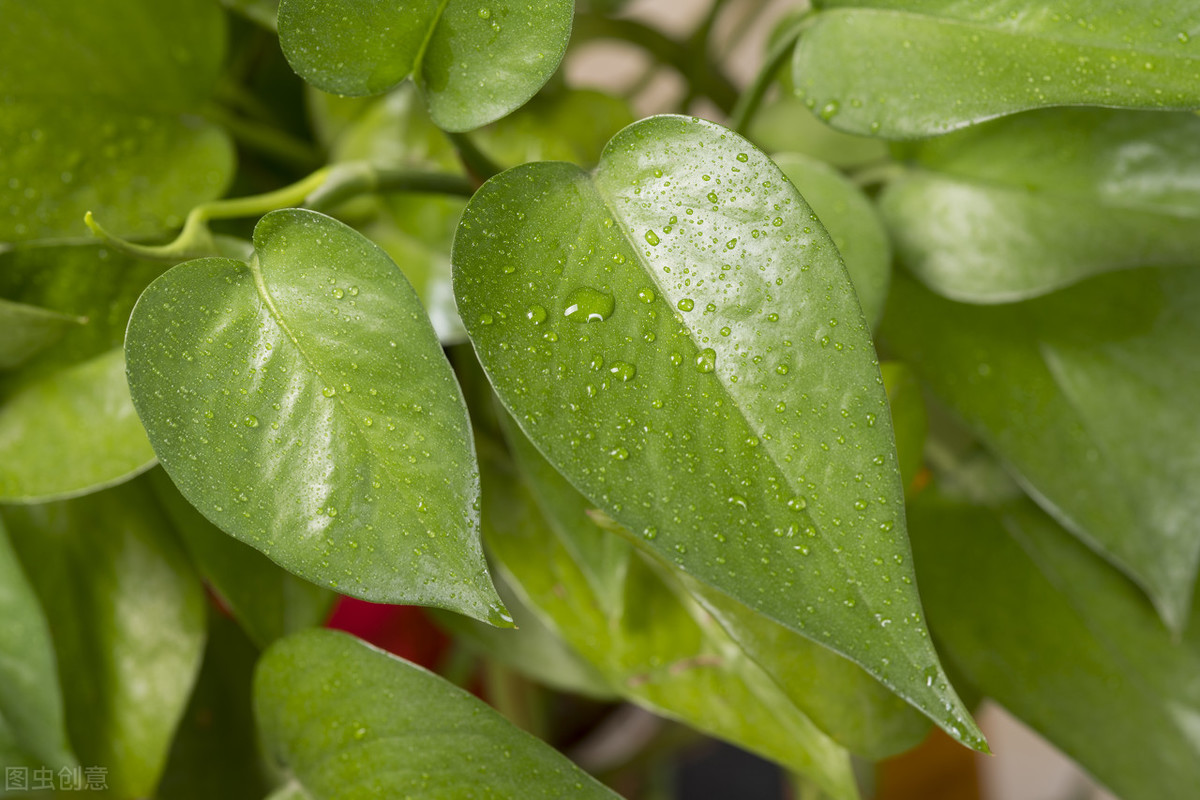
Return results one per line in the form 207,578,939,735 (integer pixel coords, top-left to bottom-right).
910,501,1200,800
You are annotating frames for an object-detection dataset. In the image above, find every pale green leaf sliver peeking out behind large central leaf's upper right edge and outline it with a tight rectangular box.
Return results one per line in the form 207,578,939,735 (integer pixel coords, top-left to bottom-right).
772,152,892,327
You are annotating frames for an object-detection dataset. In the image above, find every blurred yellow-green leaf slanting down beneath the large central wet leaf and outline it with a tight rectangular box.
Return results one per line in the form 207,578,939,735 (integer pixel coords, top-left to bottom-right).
484,433,858,800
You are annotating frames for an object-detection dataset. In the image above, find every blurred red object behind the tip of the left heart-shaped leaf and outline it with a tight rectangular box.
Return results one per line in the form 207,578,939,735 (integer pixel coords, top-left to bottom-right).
325,597,450,669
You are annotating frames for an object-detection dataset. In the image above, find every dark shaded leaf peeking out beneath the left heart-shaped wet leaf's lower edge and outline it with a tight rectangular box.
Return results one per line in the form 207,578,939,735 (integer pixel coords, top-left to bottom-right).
148,469,336,648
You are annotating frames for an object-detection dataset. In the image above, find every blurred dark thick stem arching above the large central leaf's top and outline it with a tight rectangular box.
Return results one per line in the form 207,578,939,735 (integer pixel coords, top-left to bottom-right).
574,13,738,114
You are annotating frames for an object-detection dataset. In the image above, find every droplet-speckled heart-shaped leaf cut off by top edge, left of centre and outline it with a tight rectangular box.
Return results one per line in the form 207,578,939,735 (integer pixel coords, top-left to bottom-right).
280,0,574,131
